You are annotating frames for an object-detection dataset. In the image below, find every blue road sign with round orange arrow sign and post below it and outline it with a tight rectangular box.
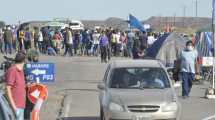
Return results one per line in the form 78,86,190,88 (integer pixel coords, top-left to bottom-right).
25,63,55,120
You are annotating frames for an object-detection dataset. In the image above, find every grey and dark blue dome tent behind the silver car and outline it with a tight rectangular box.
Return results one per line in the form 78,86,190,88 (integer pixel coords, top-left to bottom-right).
147,32,187,67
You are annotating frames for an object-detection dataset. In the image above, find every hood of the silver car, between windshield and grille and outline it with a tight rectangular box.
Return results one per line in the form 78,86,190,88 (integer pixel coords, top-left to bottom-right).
110,89,174,105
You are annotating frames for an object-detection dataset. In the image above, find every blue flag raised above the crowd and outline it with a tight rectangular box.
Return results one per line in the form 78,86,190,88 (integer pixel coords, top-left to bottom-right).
129,14,145,32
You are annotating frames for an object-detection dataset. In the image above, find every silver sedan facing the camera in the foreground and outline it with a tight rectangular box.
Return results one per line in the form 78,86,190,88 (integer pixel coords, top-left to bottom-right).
98,59,181,120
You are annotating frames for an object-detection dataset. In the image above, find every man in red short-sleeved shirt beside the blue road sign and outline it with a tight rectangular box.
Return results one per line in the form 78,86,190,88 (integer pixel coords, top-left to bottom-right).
5,52,26,120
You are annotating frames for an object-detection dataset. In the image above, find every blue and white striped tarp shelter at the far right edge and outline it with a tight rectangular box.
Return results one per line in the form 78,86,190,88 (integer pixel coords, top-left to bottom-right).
195,31,213,57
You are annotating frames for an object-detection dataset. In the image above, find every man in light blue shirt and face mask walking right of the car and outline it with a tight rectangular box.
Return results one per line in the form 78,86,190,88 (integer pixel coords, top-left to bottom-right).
179,41,199,99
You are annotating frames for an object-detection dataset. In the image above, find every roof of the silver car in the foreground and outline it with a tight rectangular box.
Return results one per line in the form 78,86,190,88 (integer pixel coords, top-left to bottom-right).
111,59,162,68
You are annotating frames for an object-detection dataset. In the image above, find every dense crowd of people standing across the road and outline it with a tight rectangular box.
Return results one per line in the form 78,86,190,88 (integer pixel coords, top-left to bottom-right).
0,26,158,62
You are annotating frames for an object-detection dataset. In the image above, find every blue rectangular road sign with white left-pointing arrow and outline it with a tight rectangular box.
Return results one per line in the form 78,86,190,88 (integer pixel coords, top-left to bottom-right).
25,63,55,83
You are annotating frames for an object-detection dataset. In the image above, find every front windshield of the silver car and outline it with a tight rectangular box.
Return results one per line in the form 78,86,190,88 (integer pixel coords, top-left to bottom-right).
109,68,170,89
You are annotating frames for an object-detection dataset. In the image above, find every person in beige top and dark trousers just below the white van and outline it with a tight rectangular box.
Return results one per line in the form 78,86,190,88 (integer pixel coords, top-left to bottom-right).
64,28,73,56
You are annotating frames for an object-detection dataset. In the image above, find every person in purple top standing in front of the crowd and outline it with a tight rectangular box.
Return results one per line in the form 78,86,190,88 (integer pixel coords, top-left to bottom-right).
99,31,109,62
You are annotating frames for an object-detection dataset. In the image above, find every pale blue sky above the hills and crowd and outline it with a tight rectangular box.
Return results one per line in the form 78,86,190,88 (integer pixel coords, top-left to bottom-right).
0,0,212,24
